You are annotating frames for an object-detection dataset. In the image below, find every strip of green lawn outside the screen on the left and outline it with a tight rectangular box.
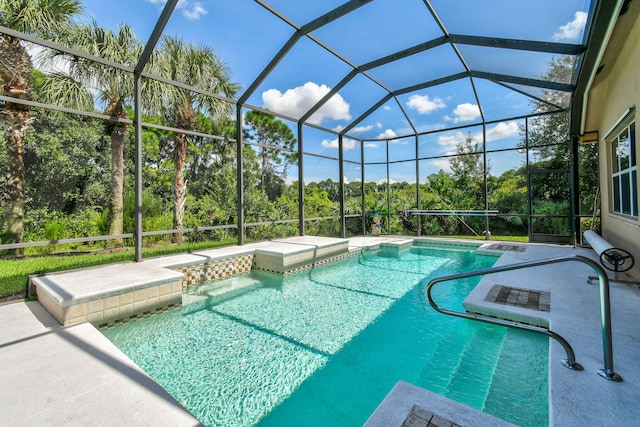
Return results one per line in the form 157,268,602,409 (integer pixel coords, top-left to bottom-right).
0,239,237,300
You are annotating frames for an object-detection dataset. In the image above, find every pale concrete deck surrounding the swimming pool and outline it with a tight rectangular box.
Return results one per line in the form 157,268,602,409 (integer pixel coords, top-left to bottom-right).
0,236,640,426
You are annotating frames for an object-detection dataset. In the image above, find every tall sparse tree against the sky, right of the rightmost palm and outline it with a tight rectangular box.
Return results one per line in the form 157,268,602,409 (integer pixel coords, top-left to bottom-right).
245,110,297,201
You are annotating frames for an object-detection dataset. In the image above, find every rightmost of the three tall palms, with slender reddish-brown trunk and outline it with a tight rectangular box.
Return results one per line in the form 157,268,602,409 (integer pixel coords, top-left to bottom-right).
154,36,240,243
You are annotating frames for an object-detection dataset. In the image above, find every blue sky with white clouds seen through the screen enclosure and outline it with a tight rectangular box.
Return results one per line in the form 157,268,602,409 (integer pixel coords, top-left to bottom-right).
84,0,590,182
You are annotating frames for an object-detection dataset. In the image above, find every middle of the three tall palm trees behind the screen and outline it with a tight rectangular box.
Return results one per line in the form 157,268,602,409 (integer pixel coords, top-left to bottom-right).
42,22,143,245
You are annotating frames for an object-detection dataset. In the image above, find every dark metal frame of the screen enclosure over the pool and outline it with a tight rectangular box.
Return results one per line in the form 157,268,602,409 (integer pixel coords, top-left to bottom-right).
0,0,622,261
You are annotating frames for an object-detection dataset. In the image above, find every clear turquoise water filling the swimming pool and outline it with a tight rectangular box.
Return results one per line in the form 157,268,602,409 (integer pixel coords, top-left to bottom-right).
103,247,548,427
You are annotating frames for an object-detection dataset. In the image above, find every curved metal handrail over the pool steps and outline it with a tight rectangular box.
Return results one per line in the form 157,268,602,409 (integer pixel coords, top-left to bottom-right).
425,255,622,382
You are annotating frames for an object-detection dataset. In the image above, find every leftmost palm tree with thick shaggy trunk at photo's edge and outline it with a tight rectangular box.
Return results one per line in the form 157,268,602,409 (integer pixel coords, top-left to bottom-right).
0,0,82,255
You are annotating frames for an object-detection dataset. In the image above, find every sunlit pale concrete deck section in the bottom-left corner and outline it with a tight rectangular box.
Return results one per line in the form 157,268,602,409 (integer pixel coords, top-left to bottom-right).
0,301,201,427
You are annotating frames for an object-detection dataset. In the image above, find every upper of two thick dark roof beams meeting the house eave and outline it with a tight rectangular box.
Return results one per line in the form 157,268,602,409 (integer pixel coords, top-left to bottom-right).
449,34,585,55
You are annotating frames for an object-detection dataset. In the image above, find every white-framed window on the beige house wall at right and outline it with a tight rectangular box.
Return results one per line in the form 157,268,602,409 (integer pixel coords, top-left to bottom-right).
611,123,638,217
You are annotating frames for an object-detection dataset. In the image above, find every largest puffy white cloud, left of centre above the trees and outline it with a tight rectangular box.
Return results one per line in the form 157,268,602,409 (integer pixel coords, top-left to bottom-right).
262,82,351,125
